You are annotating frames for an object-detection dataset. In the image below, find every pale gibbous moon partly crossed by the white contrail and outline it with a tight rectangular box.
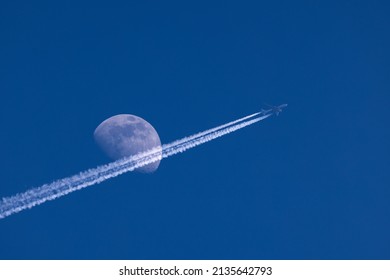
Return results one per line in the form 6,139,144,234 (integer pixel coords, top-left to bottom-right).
93,114,161,173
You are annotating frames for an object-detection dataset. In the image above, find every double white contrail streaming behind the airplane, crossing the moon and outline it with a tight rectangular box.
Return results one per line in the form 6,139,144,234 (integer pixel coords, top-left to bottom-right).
0,113,271,219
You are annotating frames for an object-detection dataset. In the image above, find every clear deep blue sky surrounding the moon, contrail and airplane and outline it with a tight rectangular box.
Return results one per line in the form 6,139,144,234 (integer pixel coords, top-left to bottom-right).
0,1,390,259
